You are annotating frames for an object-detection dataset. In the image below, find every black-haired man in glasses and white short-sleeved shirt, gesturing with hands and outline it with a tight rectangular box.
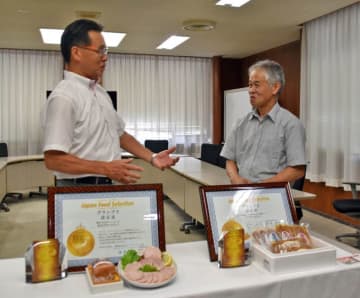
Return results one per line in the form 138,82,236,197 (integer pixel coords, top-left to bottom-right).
43,19,178,185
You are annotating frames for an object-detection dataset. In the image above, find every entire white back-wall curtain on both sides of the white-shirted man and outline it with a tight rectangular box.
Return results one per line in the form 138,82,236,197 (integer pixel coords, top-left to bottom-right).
0,50,212,155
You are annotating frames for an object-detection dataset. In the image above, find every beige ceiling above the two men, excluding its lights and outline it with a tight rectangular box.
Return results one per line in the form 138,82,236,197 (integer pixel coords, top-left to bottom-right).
0,0,358,58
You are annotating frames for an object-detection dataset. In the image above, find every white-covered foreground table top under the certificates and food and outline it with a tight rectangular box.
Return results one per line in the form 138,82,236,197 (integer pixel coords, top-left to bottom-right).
0,241,360,298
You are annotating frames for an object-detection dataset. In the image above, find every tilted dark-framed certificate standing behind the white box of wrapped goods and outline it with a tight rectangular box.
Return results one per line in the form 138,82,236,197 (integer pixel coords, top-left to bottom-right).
199,182,298,262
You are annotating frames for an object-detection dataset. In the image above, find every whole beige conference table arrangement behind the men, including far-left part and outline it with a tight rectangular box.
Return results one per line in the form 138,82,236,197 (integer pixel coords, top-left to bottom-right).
0,154,315,223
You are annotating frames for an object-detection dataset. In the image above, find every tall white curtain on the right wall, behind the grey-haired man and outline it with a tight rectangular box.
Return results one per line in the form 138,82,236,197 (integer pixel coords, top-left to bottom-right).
300,3,360,186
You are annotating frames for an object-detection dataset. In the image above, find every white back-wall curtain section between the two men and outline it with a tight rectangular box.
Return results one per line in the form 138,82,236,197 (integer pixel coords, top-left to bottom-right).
103,54,212,155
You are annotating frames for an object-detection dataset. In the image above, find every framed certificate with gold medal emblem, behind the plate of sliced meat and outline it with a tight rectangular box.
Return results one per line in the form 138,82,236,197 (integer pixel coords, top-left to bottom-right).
48,184,165,271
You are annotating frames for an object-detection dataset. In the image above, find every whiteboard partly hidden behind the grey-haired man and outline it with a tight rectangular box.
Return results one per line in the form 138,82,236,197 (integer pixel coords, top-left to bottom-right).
224,87,252,140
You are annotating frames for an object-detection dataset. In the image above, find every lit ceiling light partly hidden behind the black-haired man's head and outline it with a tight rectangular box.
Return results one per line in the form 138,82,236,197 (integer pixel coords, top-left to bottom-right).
40,28,126,47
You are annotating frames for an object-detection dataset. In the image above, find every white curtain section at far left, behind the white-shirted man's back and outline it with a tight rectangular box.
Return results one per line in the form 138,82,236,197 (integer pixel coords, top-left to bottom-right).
0,49,62,155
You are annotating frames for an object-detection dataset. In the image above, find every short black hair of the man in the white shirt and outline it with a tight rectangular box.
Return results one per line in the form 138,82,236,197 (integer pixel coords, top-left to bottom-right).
61,19,103,63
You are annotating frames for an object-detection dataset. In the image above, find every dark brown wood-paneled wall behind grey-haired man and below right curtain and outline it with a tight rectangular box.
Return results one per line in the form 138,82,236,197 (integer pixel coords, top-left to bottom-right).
213,41,360,226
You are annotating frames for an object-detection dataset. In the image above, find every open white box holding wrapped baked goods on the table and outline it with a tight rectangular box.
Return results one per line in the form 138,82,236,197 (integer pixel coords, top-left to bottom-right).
253,237,336,273
